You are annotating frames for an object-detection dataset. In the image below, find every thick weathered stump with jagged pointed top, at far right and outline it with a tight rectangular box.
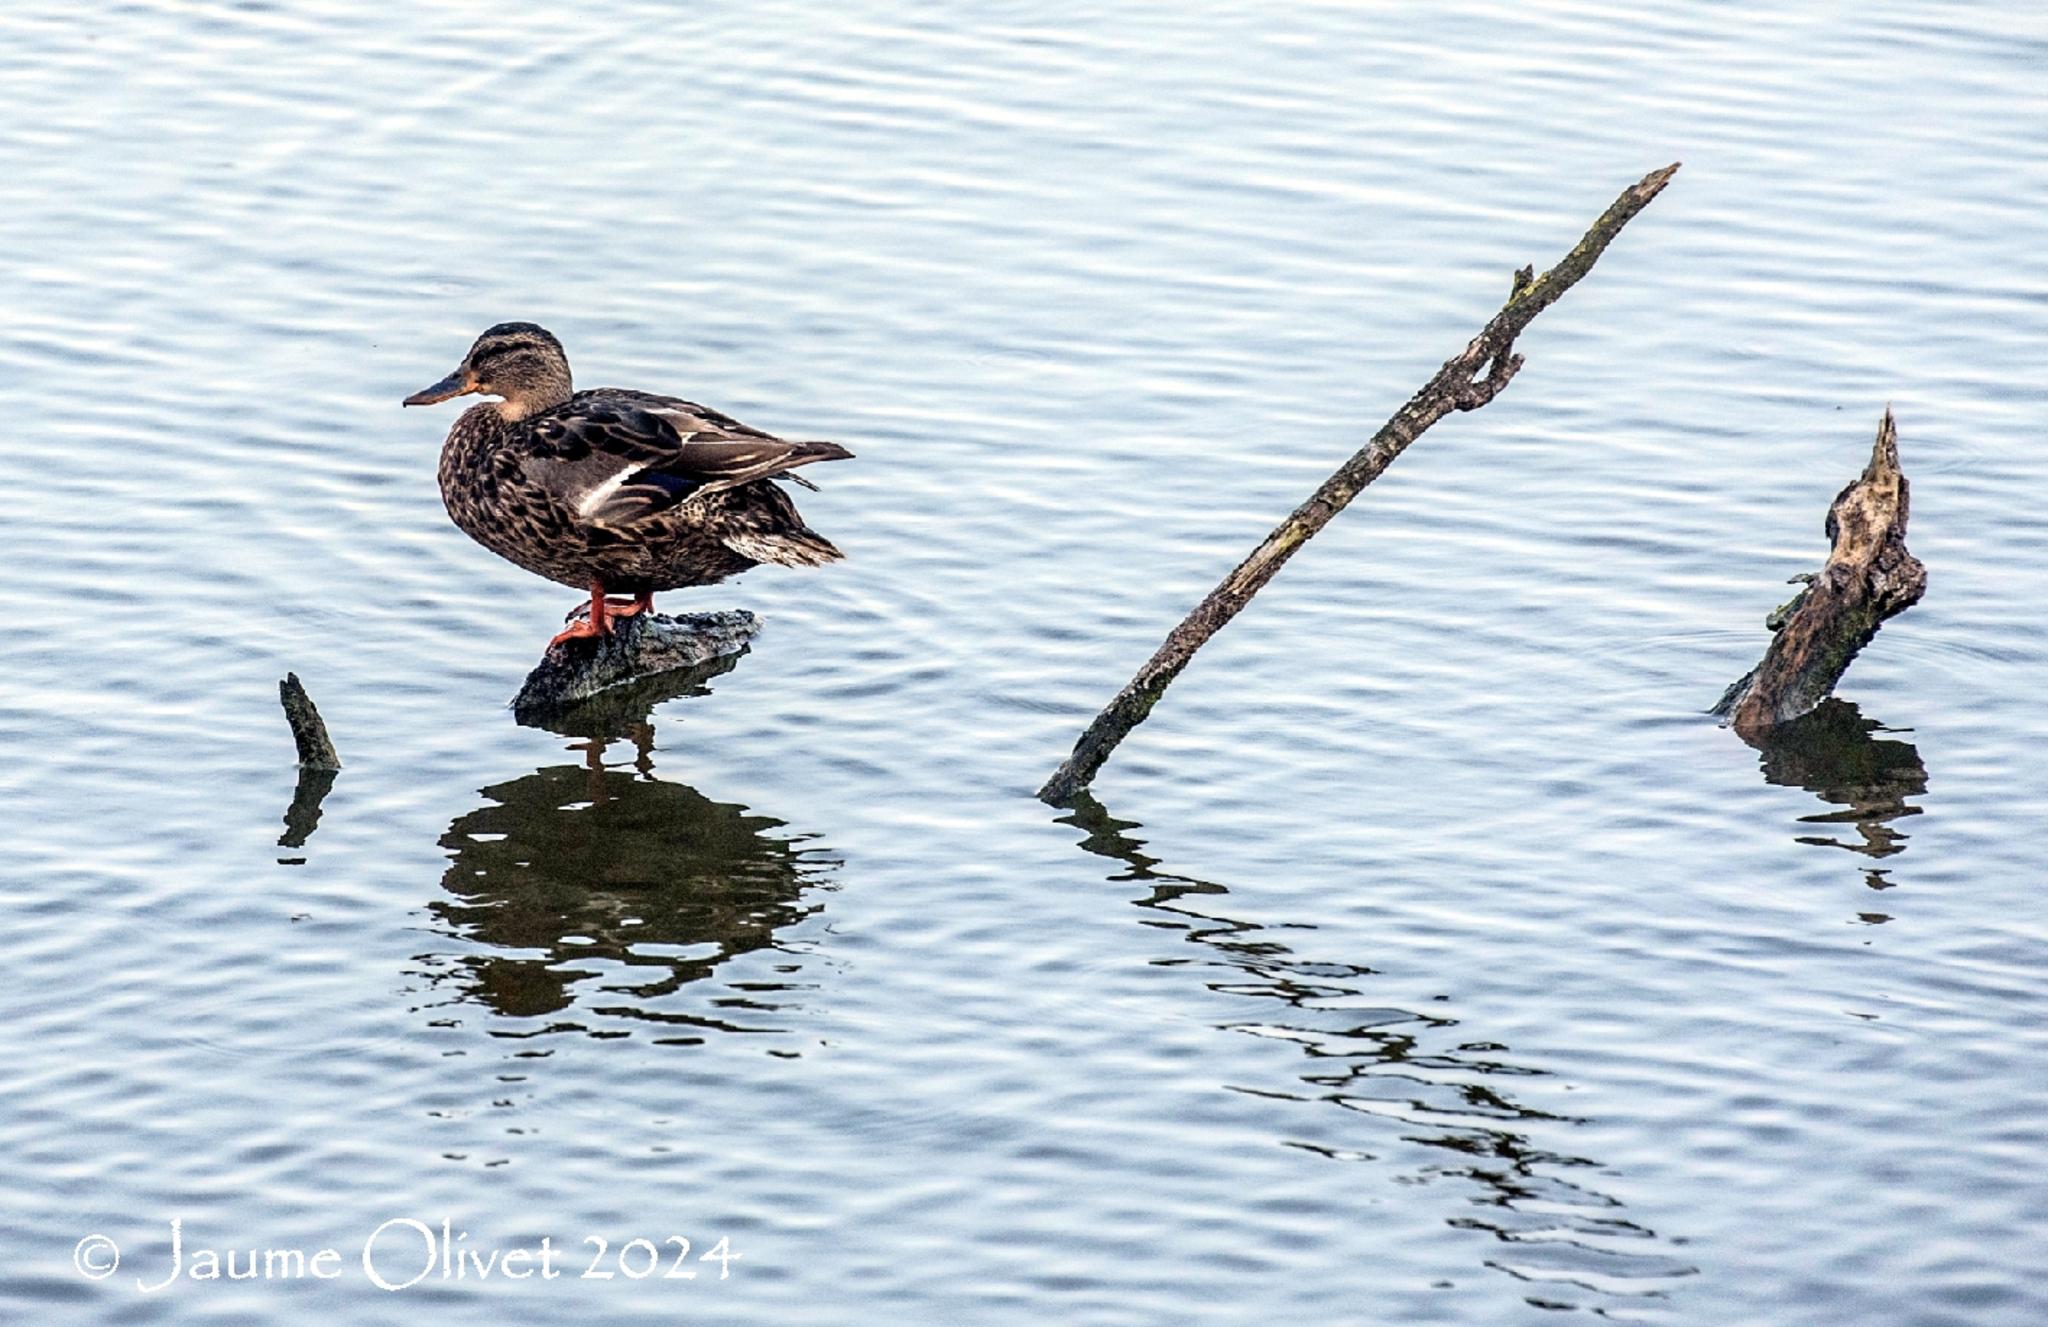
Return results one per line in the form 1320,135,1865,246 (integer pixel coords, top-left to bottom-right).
1712,408,1927,739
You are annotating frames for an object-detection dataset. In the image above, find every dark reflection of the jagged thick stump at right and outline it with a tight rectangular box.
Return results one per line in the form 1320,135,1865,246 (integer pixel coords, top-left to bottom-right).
1749,698,1927,901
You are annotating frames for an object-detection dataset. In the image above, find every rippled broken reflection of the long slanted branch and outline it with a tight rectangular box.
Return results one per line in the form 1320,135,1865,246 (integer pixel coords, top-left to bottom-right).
1063,795,1698,1315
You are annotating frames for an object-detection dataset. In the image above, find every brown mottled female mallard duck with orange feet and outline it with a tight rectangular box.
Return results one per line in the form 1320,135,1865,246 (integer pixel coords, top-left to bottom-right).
406,324,852,643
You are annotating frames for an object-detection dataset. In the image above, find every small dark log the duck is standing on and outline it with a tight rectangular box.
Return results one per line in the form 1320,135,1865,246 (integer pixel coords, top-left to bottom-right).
512,604,762,727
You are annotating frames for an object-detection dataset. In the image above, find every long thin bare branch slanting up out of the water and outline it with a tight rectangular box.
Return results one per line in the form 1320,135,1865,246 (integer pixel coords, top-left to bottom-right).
1038,162,1677,805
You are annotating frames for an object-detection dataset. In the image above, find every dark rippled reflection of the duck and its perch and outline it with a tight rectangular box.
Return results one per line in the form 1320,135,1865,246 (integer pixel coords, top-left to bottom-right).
430,664,836,1042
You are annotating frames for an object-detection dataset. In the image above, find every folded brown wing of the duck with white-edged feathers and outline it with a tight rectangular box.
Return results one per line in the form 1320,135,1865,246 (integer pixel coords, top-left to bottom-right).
520,389,852,528
